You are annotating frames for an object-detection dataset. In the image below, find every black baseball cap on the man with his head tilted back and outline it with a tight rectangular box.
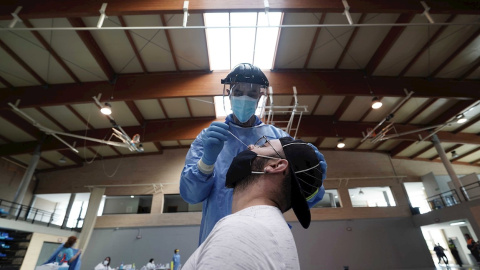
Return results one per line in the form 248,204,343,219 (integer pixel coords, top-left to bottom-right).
279,137,322,229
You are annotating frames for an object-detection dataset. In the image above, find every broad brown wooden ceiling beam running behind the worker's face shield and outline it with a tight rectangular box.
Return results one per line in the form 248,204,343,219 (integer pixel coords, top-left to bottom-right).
0,70,480,109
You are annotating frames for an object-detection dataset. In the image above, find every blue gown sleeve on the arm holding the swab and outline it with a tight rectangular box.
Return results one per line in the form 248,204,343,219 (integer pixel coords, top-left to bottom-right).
180,129,215,204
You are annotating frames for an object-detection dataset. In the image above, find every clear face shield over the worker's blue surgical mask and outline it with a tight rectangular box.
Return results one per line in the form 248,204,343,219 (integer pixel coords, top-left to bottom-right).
223,82,267,123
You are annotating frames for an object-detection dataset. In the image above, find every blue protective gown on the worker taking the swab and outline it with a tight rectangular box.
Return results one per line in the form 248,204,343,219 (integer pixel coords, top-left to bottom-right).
180,114,325,245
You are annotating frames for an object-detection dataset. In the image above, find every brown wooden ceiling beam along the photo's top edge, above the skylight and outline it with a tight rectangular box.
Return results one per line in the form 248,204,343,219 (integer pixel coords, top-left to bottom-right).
0,0,480,20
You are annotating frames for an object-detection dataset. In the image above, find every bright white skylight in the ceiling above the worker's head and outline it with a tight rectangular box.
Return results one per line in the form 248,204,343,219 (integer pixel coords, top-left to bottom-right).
205,12,282,70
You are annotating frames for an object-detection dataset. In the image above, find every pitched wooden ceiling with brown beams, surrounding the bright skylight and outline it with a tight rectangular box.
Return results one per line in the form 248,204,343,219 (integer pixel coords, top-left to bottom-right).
0,0,480,170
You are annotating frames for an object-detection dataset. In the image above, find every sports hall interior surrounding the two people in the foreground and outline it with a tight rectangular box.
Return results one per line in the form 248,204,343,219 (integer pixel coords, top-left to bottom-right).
0,0,480,270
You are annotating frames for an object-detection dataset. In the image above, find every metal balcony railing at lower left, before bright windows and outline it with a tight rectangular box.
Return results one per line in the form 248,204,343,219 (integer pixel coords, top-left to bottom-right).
0,199,83,231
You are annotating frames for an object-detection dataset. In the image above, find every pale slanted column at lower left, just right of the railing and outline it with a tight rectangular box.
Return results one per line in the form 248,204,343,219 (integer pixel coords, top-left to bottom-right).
78,188,105,251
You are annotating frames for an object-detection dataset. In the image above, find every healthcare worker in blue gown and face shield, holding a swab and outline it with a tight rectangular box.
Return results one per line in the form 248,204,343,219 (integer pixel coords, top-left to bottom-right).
180,63,327,244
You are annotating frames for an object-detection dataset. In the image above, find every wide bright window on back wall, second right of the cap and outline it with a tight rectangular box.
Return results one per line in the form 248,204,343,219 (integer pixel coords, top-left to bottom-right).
348,187,396,207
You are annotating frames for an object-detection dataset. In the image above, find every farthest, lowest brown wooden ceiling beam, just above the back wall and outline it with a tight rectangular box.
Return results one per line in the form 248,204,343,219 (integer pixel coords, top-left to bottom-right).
0,115,480,156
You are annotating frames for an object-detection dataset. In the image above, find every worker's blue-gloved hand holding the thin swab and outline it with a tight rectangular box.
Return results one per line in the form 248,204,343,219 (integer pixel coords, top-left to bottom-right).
202,122,228,165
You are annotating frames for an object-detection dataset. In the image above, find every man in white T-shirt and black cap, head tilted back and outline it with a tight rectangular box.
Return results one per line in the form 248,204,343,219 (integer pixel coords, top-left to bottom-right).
182,137,322,270
